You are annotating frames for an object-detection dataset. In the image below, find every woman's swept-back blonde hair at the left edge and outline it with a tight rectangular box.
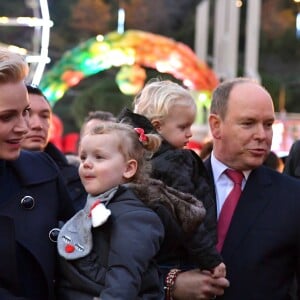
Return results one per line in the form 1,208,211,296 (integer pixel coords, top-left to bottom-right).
0,48,29,84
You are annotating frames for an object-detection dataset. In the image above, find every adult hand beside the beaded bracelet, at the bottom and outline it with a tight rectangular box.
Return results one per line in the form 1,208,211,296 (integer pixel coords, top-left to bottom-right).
172,269,229,300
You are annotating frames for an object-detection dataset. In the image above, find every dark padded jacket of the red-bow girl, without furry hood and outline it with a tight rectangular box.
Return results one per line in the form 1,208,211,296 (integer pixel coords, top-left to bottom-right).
58,186,164,300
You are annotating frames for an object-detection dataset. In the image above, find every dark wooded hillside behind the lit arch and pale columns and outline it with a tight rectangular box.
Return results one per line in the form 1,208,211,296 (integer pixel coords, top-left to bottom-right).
0,0,300,133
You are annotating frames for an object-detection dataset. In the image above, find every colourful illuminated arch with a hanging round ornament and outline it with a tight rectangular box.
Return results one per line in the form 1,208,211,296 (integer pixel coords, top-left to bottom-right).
40,30,218,105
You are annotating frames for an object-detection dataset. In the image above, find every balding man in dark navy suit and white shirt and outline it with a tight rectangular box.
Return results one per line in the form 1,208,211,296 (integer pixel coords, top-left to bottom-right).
173,78,300,300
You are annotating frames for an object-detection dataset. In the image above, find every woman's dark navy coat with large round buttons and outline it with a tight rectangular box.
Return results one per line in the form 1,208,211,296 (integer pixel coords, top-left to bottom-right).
0,151,75,300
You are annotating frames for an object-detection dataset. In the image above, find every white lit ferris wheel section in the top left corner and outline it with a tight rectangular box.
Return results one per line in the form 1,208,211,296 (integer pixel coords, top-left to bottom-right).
0,0,53,85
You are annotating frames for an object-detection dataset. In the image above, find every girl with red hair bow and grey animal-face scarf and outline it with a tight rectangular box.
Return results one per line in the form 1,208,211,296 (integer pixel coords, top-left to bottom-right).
58,123,225,300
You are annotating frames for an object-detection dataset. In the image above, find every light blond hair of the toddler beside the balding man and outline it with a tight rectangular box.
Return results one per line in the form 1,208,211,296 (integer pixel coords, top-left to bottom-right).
134,80,197,121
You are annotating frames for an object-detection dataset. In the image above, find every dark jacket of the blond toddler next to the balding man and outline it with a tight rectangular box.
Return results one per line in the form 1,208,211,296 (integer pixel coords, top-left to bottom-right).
118,108,221,272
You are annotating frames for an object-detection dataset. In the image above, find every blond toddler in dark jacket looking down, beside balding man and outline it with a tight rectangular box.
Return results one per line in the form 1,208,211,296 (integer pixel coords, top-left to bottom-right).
118,80,225,299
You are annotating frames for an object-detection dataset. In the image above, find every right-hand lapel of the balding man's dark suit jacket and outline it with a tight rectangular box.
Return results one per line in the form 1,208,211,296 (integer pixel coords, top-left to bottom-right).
222,167,274,259
